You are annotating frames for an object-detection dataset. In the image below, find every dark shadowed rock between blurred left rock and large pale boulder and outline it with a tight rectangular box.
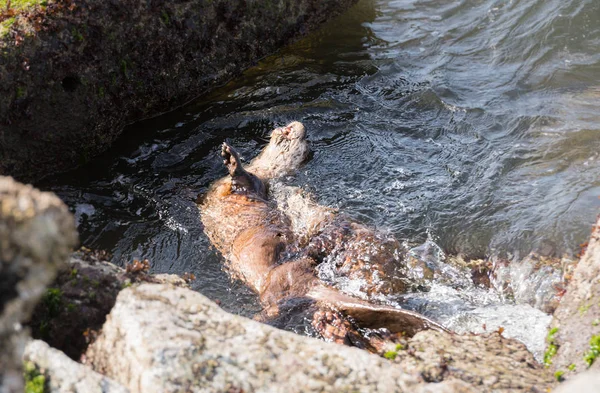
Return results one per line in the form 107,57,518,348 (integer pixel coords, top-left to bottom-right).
29,252,187,360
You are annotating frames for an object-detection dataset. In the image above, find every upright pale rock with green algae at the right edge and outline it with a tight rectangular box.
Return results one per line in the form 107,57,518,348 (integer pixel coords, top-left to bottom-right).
546,219,600,378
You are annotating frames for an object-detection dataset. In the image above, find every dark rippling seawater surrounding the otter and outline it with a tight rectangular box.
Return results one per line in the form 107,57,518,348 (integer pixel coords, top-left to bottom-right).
46,0,600,356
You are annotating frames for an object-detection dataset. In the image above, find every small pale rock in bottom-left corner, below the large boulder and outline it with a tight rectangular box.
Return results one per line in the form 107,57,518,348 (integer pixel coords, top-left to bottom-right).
23,340,129,393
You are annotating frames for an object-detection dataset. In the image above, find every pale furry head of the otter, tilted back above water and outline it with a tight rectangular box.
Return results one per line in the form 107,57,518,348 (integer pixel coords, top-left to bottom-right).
252,121,310,178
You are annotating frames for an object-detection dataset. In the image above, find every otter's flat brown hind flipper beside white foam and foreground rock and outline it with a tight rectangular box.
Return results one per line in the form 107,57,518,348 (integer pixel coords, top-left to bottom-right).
307,285,449,337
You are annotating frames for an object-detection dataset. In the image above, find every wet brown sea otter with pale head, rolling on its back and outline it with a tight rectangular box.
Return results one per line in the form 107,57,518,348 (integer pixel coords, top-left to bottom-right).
199,122,444,347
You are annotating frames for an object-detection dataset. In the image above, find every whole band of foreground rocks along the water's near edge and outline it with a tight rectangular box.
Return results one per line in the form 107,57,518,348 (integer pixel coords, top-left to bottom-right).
0,178,600,393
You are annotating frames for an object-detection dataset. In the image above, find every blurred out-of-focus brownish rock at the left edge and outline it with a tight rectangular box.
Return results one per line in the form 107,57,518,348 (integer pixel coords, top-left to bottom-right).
0,177,77,393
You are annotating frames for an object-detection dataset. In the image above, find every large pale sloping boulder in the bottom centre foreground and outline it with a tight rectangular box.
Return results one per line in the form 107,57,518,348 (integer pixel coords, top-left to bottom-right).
87,284,550,392
